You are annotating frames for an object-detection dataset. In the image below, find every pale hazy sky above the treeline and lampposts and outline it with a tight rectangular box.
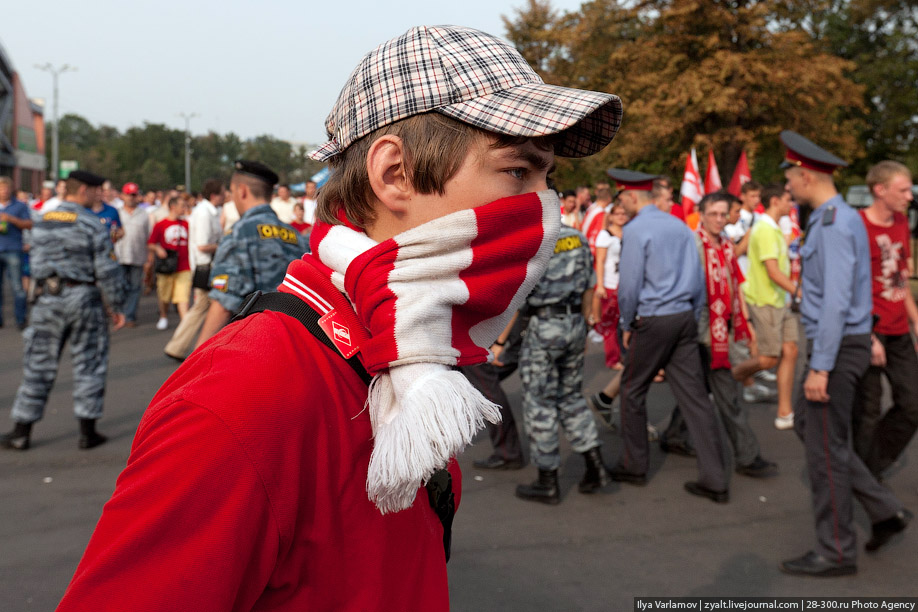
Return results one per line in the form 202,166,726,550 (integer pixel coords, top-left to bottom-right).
0,0,580,144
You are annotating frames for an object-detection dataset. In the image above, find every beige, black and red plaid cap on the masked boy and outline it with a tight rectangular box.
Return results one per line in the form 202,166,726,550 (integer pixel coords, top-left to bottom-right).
309,26,622,161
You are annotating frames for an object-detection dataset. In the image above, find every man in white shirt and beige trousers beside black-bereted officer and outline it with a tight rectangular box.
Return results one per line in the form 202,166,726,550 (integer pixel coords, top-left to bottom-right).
165,179,225,361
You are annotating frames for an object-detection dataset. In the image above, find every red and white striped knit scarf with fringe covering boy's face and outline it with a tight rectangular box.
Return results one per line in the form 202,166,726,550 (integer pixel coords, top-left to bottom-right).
310,191,560,513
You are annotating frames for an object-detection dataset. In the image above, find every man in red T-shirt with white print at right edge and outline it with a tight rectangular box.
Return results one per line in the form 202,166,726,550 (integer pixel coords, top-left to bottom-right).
852,161,918,477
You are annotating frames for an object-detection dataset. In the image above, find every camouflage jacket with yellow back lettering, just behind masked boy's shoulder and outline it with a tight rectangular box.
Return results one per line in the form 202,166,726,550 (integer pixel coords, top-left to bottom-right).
210,204,309,312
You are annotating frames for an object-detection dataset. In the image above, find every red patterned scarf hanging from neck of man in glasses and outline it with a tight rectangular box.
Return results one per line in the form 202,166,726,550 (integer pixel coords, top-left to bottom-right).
696,225,749,370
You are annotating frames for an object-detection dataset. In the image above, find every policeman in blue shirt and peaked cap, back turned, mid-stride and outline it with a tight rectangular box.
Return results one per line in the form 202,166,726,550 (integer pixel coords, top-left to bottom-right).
608,169,730,503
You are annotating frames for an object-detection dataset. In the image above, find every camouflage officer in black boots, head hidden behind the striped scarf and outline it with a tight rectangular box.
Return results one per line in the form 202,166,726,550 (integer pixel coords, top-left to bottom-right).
516,225,610,504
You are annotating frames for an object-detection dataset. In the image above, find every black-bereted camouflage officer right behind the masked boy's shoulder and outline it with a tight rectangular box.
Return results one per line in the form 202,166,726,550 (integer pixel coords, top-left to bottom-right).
197,160,309,346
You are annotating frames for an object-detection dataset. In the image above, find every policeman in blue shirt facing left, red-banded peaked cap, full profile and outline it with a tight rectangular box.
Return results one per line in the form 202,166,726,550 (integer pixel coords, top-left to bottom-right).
781,131,911,576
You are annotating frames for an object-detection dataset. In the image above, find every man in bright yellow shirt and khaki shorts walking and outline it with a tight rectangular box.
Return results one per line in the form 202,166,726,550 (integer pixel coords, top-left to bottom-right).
733,185,799,429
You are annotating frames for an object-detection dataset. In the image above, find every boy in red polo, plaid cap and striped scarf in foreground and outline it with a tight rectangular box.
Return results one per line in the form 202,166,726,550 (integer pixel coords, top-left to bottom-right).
59,26,621,612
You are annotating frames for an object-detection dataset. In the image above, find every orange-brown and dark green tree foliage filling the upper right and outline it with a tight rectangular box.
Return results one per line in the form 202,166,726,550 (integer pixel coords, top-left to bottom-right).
504,0,918,185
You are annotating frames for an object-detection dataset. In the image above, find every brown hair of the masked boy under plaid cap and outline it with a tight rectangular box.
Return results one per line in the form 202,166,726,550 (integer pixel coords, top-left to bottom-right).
316,112,553,228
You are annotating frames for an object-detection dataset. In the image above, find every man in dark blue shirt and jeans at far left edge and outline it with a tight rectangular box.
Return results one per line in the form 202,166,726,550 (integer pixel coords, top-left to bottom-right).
0,176,32,329
